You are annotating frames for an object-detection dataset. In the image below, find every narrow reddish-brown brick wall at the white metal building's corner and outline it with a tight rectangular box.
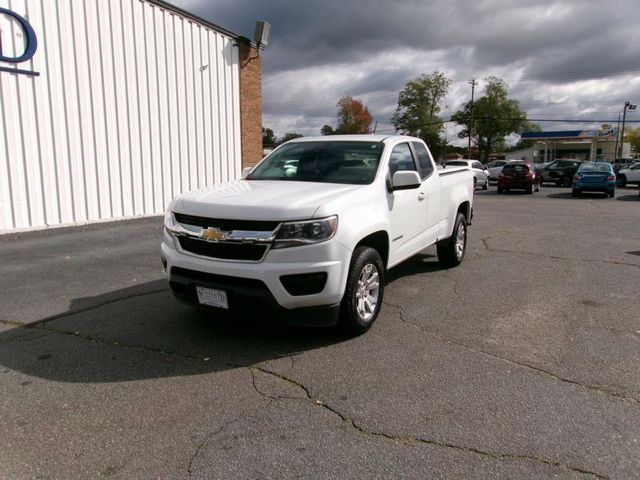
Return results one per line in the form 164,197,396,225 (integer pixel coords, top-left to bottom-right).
240,43,262,168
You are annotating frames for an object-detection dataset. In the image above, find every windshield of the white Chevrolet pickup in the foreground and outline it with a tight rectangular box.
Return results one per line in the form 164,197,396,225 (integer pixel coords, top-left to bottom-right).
247,141,384,184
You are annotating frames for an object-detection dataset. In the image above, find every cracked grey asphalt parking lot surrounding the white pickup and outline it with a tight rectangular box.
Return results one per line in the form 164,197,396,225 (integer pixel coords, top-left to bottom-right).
0,186,640,479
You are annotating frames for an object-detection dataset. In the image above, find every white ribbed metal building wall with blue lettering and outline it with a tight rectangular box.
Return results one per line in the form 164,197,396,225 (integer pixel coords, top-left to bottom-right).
0,0,241,232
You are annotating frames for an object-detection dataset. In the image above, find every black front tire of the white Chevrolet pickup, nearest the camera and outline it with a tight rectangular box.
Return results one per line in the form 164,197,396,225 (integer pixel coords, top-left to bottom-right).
338,247,385,336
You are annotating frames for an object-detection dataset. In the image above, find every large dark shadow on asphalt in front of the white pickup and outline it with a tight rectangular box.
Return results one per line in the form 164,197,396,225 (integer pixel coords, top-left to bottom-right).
0,279,346,383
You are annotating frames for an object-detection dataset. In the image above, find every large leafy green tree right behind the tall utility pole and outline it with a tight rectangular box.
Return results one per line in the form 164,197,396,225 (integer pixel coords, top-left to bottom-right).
451,77,530,162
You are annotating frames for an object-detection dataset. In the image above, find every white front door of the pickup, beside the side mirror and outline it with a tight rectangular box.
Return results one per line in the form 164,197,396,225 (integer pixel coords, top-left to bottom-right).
388,142,427,264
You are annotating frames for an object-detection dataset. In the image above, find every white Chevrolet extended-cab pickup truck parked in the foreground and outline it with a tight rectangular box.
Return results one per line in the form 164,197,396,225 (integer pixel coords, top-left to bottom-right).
161,135,473,334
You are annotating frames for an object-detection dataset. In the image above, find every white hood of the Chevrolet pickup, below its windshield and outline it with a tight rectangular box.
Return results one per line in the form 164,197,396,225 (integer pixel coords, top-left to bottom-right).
169,180,362,221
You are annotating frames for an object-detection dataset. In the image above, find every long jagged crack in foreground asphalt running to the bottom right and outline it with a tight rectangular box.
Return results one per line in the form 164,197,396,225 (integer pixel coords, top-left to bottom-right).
250,365,609,480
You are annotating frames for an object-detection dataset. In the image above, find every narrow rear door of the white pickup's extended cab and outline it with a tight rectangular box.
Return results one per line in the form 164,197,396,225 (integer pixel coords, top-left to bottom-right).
411,142,444,246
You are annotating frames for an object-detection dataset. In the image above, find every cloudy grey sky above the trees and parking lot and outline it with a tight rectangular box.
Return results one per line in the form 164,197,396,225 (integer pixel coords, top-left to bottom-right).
172,0,640,144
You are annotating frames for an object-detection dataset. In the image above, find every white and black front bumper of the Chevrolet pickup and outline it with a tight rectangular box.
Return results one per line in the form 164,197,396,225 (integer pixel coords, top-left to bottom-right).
161,231,351,316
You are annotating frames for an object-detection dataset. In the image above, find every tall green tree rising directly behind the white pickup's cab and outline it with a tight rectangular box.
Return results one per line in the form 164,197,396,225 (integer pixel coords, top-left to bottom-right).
391,71,451,147
